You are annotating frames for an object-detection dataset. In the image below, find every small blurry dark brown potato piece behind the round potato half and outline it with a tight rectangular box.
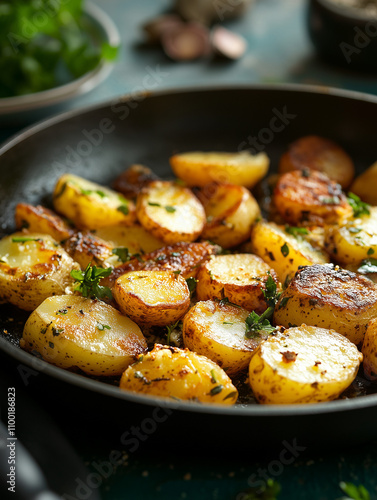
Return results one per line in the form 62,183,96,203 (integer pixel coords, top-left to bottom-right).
112,164,158,200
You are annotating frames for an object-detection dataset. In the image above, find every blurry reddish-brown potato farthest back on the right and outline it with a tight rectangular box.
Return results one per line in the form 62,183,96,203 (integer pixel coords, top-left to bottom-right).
279,135,355,188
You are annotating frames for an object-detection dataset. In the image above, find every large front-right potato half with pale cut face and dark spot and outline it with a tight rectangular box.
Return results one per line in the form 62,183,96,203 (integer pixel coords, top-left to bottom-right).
249,325,363,404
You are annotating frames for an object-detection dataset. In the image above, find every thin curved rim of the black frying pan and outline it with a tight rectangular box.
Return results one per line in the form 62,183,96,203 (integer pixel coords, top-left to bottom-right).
0,83,377,418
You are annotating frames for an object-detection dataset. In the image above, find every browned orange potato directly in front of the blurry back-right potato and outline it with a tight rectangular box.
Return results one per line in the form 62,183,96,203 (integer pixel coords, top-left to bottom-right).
274,169,353,226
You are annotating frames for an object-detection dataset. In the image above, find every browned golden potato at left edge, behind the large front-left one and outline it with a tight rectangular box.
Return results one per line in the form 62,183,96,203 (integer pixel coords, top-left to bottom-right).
0,232,79,311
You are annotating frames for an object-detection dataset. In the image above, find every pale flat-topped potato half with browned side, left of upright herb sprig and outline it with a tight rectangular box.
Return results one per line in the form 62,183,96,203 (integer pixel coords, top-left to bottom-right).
196,254,278,313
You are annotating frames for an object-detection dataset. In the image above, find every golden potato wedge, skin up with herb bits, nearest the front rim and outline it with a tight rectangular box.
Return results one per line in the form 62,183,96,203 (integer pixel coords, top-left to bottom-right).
119,344,238,405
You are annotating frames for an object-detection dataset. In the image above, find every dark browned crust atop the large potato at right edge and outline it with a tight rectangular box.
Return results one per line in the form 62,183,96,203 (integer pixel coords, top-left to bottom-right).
284,264,377,312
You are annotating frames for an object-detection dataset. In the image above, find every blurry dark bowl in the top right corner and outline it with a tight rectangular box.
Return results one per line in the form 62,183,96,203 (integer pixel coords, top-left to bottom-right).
308,0,377,73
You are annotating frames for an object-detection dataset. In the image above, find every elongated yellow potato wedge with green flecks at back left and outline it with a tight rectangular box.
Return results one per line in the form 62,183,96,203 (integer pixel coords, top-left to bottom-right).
53,174,136,229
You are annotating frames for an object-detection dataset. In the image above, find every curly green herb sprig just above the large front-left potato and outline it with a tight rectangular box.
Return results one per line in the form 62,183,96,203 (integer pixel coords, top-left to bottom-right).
71,264,113,299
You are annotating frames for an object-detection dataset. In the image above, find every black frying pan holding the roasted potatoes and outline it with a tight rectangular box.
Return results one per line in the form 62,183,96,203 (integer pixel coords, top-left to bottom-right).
0,86,377,449
